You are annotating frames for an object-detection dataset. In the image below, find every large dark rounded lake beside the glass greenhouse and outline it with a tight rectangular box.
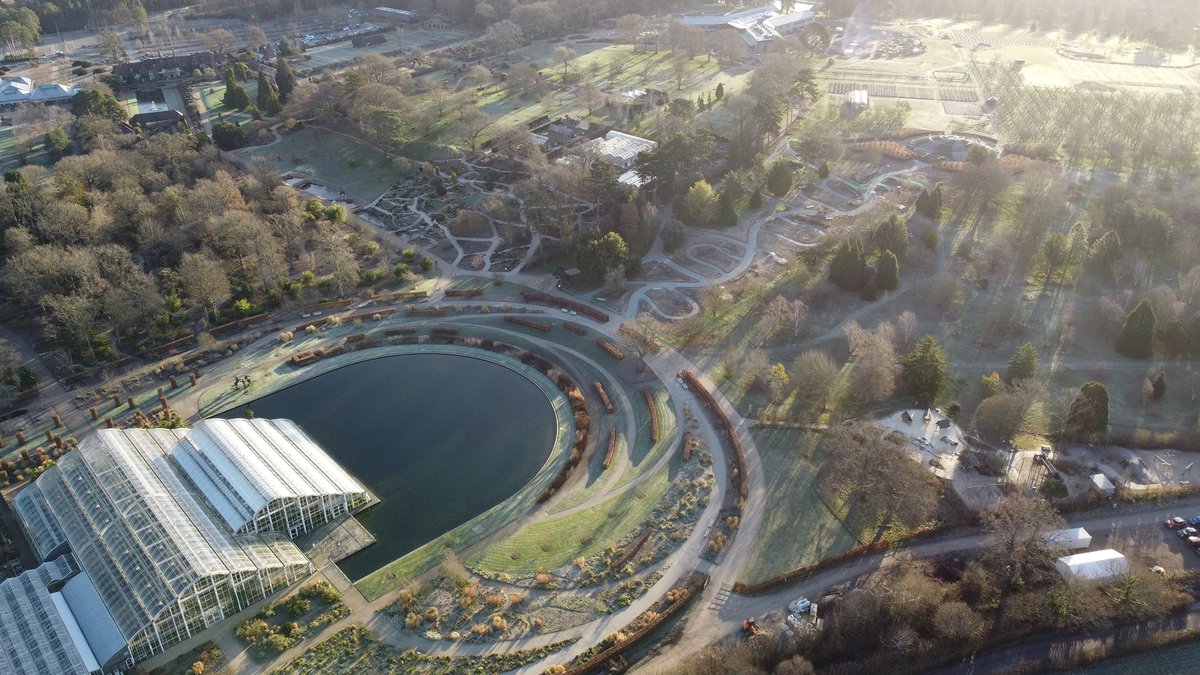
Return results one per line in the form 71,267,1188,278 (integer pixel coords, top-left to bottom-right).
221,354,556,580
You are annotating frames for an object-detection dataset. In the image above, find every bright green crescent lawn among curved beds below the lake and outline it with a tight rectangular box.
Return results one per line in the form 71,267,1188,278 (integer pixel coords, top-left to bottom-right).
467,467,671,574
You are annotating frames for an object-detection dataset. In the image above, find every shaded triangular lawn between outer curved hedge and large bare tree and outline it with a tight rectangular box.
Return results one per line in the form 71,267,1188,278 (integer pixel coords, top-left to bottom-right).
742,429,858,583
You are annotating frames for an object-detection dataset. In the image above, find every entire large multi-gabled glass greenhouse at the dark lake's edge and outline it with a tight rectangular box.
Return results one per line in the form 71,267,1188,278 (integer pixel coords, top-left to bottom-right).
0,419,371,673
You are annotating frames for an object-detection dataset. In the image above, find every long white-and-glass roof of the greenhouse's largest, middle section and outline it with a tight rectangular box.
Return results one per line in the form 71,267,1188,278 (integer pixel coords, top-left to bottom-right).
27,429,314,640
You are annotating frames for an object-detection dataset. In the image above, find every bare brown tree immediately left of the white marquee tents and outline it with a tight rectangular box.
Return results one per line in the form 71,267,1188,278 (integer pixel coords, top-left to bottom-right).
979,490,1063,587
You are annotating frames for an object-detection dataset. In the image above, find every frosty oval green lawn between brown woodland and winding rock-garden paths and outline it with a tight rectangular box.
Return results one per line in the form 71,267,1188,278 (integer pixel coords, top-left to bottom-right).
238,129,400,202
